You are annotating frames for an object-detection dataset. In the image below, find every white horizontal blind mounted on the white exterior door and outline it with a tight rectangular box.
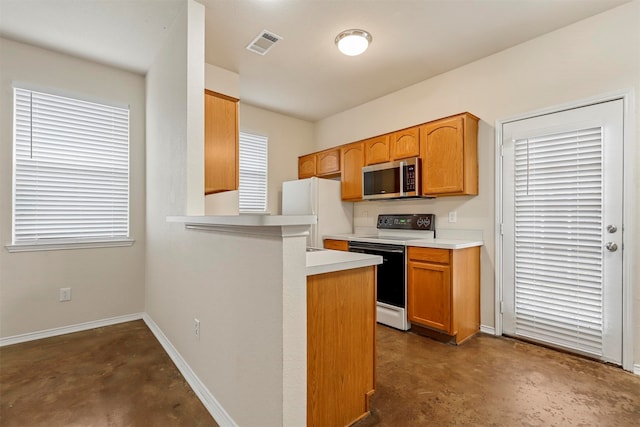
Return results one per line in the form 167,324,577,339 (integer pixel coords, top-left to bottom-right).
515,128,603,356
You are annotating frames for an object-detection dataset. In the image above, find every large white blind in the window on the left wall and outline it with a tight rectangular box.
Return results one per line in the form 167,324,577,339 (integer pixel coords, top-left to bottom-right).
13,88,129,244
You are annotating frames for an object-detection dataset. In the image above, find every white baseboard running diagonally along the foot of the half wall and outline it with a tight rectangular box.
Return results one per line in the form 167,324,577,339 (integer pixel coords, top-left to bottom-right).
142,313,238,427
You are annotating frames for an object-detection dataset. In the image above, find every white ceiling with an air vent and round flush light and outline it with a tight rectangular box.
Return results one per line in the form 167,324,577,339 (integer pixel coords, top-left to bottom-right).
0,0,629,121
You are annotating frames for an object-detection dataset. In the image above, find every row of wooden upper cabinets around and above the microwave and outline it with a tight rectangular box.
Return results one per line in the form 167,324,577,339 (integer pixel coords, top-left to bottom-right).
298,113,478,201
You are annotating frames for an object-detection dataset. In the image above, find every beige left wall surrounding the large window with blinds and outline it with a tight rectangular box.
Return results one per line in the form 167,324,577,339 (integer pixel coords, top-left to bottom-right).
0,39,145,337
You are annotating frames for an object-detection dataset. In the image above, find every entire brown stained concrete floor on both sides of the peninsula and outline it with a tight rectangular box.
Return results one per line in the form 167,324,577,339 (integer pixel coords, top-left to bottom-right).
0,321,640,427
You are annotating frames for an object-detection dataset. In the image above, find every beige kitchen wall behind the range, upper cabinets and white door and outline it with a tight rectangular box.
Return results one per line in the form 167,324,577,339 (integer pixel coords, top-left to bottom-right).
316,1,640,363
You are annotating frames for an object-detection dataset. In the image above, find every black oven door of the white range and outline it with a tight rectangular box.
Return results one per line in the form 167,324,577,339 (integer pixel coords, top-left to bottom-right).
349,242,406,308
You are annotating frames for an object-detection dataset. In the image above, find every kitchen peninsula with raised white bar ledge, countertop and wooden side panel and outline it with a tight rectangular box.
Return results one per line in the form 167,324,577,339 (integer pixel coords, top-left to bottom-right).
167,215,382,426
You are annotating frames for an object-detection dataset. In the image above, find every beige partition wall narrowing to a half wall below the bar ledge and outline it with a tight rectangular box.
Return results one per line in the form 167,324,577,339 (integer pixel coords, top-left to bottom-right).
146,1,284,426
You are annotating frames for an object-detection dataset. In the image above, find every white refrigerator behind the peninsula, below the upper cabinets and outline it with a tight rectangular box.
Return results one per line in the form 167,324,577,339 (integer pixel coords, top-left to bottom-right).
282,177,353,248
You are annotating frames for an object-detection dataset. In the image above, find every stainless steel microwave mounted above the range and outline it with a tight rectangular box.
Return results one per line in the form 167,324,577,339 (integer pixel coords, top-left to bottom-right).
362,157,420,200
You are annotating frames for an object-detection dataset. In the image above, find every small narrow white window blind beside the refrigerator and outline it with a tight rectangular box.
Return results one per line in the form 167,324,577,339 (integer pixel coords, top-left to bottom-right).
239,132,268,212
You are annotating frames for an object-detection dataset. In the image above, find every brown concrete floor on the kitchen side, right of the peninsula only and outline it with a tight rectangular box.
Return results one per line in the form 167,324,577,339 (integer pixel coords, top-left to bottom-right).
356,325,640,427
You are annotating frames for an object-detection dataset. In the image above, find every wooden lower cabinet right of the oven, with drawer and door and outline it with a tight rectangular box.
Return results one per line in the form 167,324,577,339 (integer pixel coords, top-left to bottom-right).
407,246,480,344
